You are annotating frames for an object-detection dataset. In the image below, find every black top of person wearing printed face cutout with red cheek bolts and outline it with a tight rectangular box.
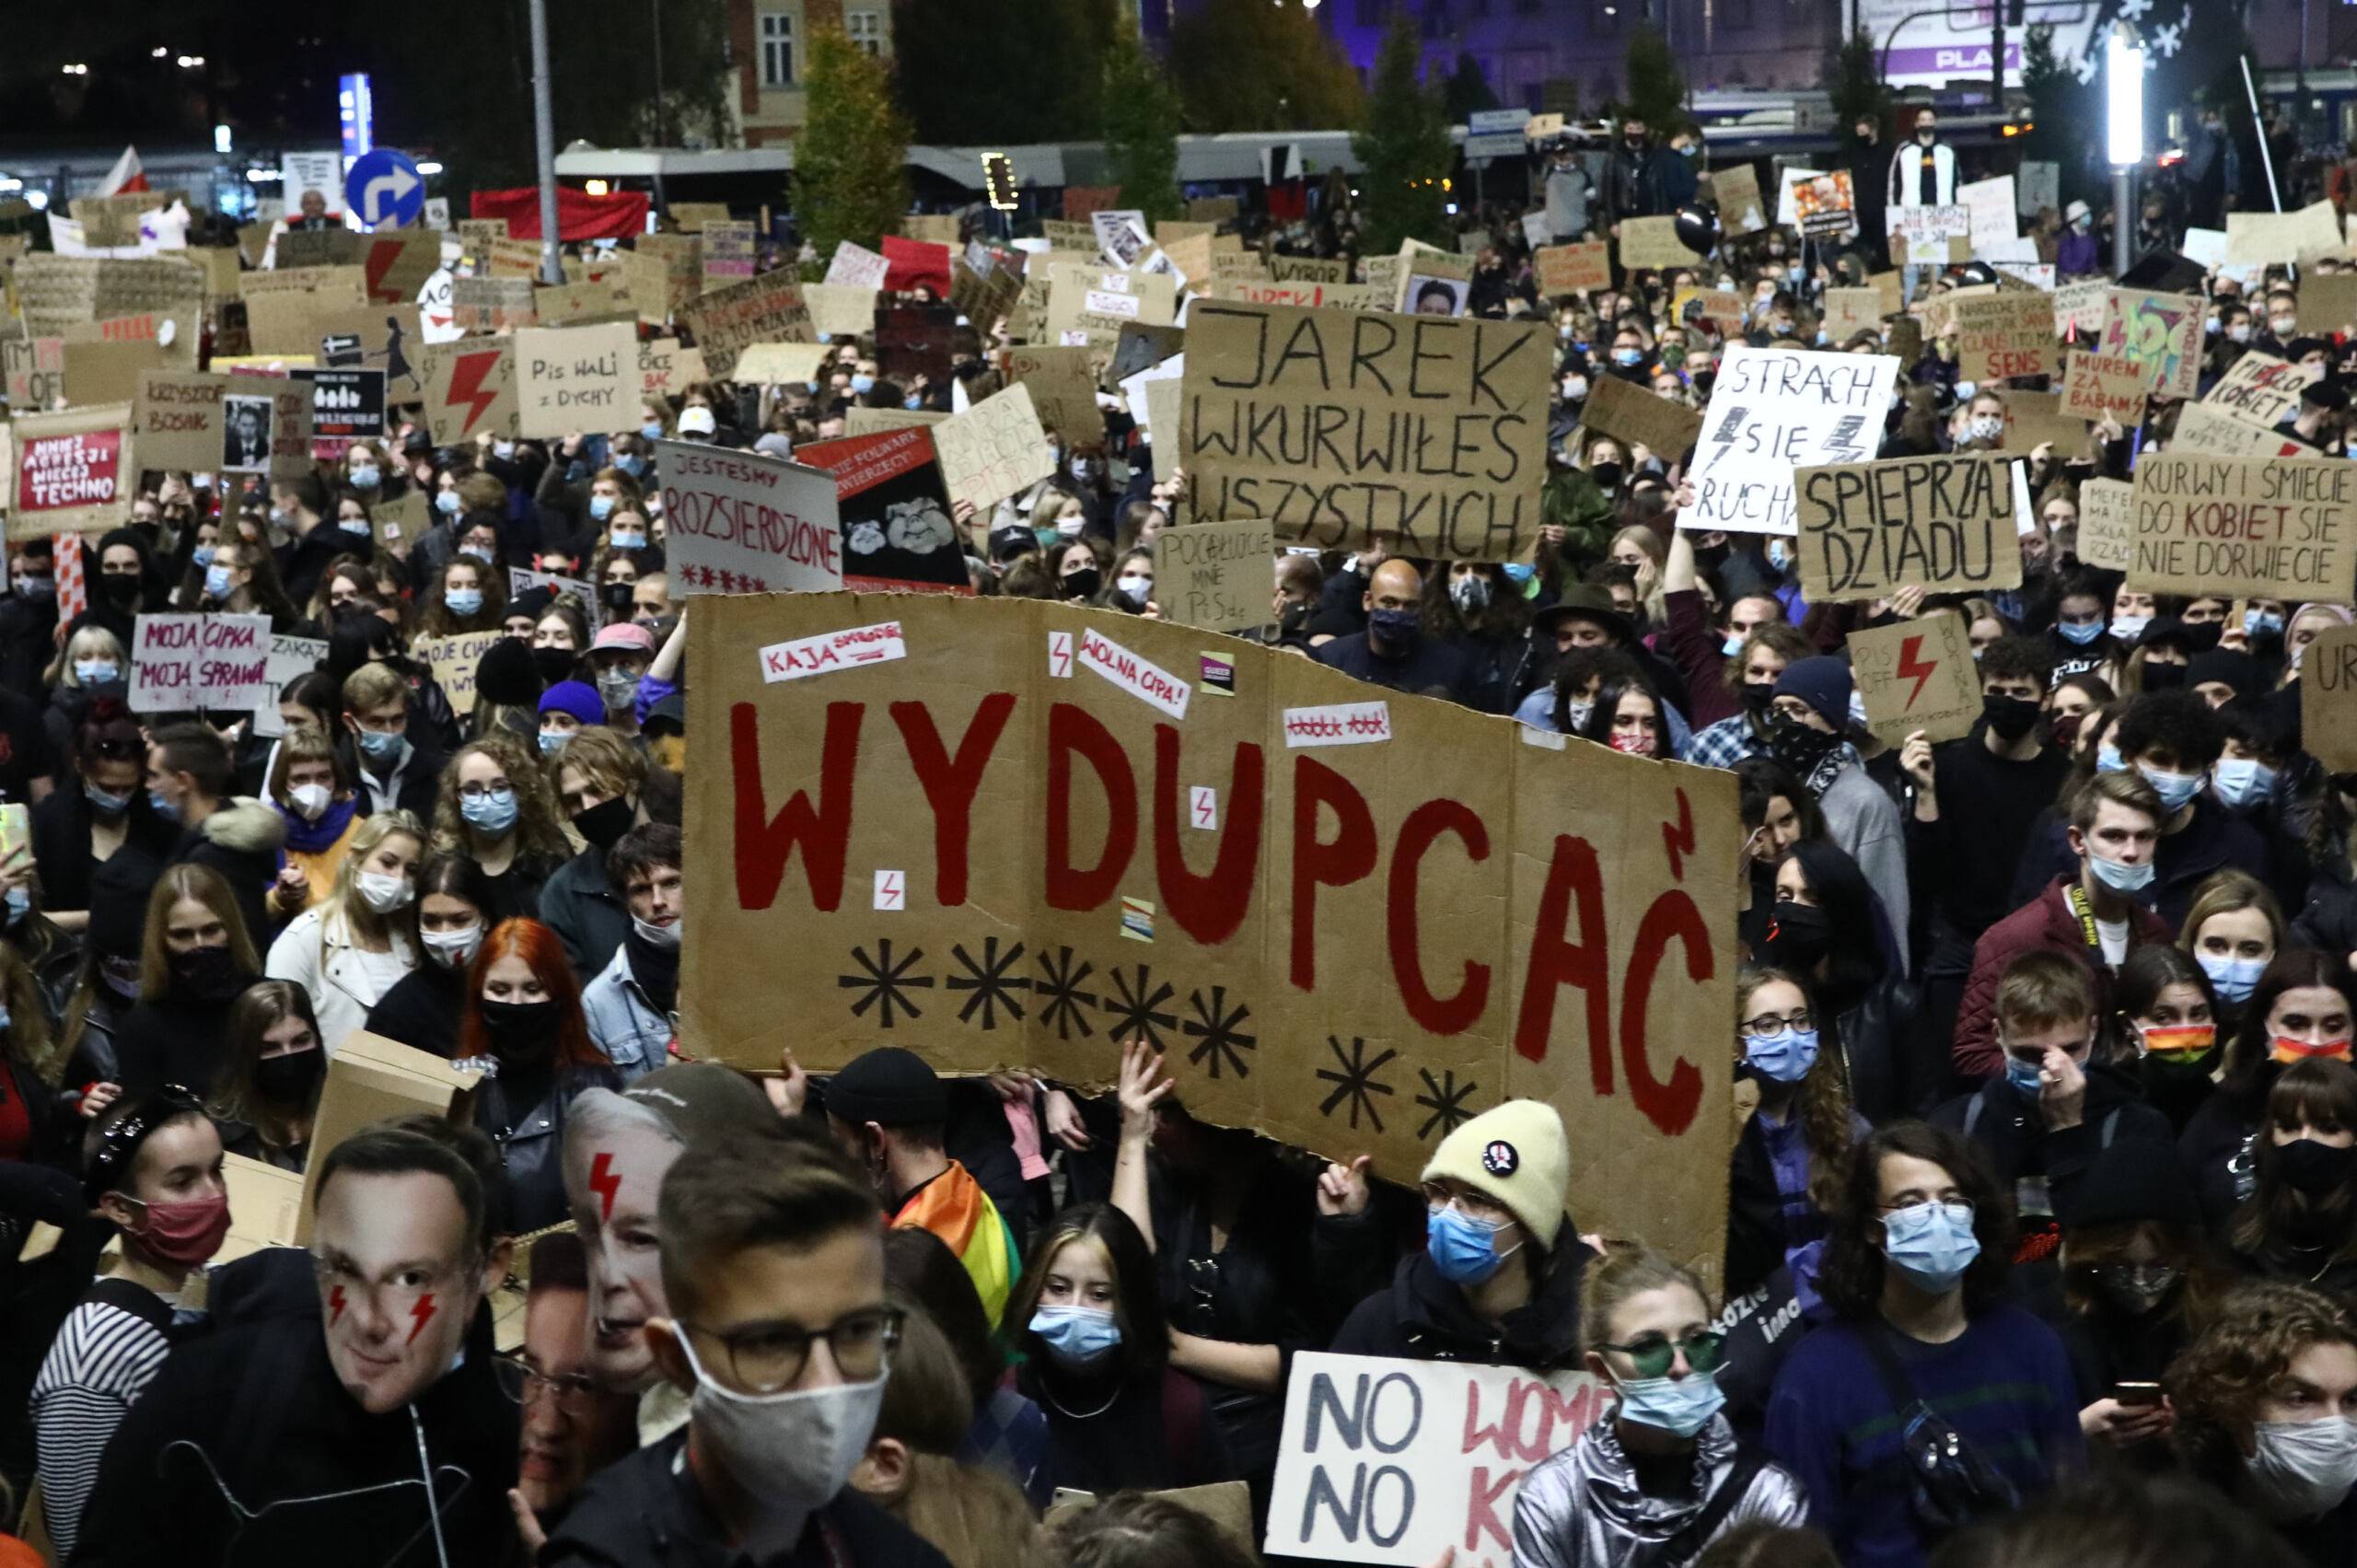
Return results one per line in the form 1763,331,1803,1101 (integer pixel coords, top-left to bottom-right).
73,1308,518,1568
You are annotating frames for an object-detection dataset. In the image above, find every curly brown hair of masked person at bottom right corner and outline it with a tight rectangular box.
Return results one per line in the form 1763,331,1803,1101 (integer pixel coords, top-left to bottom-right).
2162,1281,2357,1490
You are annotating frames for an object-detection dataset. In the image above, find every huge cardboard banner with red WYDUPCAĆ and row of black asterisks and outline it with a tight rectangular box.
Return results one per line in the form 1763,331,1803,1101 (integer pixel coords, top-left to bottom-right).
681,594,1739,1266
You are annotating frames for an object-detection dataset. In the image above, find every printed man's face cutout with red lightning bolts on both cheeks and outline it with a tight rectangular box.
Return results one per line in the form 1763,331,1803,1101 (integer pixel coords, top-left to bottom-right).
311,1172,490,1415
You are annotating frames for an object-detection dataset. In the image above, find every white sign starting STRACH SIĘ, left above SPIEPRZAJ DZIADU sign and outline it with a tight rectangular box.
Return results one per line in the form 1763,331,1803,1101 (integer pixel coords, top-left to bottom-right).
1678,344,1899,533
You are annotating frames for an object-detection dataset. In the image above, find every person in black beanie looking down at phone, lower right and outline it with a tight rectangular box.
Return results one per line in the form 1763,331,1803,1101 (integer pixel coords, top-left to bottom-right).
2044,1139,2235,1469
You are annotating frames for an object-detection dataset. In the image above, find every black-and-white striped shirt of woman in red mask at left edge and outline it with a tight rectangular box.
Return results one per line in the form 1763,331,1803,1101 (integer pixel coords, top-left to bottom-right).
33,1302,172,1561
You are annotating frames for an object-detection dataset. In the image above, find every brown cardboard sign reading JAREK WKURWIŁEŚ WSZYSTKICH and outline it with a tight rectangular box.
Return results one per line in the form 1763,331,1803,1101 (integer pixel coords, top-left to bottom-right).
1178,299,1553,561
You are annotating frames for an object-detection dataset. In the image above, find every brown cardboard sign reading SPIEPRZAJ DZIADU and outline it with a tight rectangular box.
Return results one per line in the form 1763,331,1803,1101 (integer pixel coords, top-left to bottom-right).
1794,453,2022,601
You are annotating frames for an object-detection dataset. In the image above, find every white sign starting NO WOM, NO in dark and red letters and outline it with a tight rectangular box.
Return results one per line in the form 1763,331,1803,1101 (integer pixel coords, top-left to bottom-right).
1261,1351,1612,1568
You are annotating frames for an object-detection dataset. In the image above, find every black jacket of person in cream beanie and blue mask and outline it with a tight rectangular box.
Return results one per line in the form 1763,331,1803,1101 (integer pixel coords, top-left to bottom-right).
1329,1226,1594,1372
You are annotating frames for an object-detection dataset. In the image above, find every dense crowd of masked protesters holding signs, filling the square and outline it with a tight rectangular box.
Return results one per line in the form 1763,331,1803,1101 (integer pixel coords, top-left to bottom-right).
18,76,2357,1568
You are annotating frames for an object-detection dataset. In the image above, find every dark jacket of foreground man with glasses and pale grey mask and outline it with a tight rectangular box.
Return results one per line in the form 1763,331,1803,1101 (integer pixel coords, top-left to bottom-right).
540,1429,950,1568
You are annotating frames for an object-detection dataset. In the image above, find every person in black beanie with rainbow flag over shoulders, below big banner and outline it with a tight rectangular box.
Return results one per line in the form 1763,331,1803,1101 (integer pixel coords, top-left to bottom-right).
822,1044,1023,1325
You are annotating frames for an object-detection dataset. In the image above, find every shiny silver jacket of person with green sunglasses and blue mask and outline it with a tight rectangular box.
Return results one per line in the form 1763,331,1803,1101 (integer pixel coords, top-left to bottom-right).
1514,1415,1808,1568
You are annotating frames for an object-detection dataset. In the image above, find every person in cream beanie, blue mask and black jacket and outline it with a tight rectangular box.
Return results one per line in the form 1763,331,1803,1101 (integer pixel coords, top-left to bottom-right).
1329,1098,1594,1372
